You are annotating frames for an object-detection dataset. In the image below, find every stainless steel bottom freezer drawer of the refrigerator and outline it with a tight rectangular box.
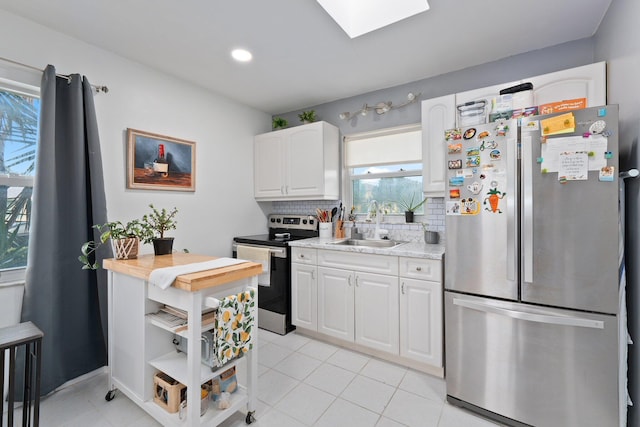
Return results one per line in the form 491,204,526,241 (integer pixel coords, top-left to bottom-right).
445,292,618,427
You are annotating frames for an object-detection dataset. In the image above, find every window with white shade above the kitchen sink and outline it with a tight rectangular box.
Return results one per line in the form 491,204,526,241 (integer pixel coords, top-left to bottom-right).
344,125,424,215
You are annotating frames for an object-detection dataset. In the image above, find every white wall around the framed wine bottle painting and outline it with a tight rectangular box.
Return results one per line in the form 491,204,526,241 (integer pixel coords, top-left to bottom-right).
0,11,271,256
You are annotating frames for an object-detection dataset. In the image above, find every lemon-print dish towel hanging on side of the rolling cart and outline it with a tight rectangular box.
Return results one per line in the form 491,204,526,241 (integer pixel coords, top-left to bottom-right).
214,288,257,366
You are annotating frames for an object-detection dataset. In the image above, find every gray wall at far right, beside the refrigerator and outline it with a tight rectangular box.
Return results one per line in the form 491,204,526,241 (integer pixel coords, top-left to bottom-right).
594,0,640,426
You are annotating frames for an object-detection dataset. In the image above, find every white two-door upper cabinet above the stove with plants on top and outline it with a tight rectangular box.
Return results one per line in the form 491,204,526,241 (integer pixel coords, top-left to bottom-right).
254,122,340,201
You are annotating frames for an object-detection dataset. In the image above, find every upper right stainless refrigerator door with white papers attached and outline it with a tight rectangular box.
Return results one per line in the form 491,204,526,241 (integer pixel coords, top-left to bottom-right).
521,106,619,314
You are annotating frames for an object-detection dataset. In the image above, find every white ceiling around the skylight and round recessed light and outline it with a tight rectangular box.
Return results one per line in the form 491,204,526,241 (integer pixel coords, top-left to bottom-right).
0,0,611,114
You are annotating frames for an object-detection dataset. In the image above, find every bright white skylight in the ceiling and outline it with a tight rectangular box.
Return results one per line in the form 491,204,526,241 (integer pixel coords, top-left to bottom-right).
317,0,429,38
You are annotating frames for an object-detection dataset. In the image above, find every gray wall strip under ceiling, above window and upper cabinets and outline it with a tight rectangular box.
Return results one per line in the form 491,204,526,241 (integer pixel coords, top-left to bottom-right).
274,39,594,135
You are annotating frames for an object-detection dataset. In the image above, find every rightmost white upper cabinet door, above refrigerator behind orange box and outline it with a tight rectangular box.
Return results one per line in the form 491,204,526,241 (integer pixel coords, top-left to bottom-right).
523,62,607,107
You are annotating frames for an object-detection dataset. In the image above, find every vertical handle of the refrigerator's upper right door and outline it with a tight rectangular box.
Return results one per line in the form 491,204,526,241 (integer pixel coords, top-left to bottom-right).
521,135,533,283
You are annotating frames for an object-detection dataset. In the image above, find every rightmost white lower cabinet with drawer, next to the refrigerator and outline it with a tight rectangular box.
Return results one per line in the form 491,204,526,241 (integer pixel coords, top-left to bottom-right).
400,257,443,367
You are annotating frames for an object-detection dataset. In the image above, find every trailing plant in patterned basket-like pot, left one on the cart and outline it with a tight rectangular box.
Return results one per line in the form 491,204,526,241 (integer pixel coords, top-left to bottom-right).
78,219,145,270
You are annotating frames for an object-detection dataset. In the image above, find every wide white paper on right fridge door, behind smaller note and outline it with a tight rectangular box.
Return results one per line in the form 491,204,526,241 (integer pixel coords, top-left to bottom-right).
540,135,607,173
